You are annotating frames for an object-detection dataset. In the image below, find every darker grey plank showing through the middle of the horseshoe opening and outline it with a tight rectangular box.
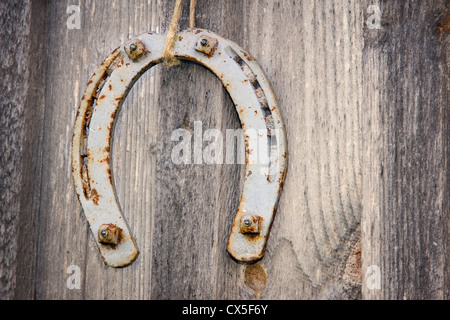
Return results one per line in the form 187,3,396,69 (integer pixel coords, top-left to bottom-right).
144,1,248,299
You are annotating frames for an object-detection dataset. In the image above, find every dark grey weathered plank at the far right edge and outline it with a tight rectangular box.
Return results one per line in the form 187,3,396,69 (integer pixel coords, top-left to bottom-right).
362,1,449,299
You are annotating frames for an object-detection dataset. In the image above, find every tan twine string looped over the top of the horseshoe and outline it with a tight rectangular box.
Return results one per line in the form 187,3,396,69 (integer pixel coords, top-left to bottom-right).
163,0,197,67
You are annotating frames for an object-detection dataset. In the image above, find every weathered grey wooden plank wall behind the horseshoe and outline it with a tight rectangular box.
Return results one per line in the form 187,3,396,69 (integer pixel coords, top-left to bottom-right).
0,0,450,299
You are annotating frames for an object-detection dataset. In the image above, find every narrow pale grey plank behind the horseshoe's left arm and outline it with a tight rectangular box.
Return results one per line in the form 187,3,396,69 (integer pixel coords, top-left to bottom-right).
83,1,161,299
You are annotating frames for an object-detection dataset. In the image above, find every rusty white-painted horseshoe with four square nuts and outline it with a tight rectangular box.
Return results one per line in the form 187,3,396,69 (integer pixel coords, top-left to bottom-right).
72,29,287,268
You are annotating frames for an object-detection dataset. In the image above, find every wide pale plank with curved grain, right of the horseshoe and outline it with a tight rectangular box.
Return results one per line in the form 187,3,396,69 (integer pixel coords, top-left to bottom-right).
241,1,363,299
